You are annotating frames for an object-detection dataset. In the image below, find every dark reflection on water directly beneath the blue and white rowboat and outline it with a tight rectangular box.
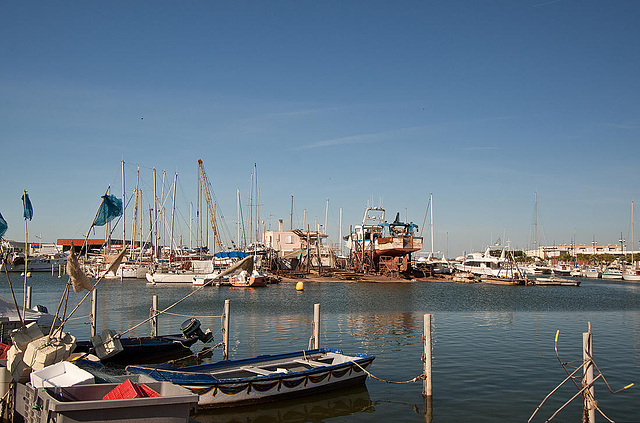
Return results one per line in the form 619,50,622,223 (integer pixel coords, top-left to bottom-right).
193,386,373,423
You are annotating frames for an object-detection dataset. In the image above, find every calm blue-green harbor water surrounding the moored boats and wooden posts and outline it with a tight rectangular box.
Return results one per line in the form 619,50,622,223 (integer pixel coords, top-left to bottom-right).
0,273,640,422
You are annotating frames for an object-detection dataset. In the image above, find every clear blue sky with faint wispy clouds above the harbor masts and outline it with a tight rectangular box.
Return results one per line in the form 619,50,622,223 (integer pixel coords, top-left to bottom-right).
0,0,640,256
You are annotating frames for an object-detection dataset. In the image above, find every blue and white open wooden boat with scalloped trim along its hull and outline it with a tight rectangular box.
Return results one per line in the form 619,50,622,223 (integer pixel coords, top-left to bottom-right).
126,348,375,407
